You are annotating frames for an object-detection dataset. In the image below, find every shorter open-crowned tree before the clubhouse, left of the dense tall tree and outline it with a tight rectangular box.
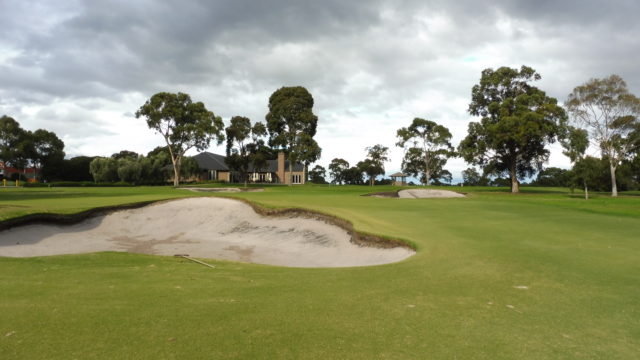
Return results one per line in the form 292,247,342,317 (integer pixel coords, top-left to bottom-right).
225,116,267,187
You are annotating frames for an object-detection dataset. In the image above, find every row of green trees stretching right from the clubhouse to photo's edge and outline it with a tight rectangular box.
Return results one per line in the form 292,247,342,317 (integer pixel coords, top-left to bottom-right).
311,66,640,200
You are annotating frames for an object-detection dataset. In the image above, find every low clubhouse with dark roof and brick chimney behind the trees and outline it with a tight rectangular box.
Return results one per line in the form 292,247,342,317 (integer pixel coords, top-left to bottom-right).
193,151,306,185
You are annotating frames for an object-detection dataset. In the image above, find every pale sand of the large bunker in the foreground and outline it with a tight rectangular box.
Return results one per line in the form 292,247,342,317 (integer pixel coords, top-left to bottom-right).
0,198,414,267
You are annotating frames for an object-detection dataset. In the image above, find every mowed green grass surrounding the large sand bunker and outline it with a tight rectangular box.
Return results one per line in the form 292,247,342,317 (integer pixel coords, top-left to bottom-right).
0,186,640,359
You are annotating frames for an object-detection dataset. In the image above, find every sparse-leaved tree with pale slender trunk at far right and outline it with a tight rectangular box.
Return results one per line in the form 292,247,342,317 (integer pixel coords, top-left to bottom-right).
567,75,640,196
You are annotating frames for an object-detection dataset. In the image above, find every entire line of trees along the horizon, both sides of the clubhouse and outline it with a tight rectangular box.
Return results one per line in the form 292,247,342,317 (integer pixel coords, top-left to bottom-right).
0,66,640,196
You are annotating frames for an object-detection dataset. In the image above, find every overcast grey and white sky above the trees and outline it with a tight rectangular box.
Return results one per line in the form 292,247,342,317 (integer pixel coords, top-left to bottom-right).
0,0,640,178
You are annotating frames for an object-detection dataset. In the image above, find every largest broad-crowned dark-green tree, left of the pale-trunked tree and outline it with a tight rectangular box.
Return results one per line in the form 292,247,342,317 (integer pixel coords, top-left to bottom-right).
458,66,566,193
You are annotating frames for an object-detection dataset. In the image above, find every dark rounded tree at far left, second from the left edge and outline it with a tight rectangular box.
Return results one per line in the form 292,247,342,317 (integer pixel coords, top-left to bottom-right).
31,129,65,181
